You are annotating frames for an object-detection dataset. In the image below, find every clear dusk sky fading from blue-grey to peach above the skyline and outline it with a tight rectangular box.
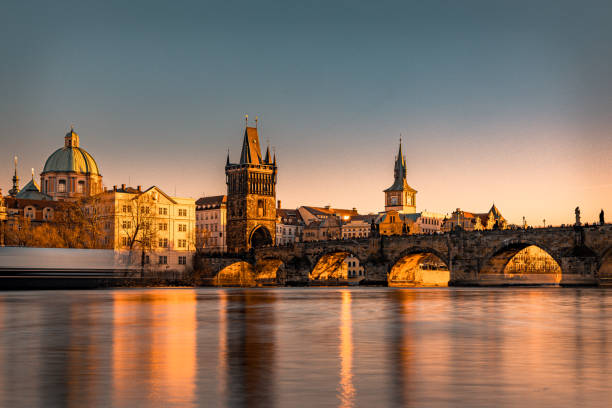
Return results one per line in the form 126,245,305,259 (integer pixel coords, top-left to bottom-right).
0,0,612,226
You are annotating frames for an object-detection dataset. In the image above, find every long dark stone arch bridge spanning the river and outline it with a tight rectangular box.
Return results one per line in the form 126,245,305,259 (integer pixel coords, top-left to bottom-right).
201,225,612,286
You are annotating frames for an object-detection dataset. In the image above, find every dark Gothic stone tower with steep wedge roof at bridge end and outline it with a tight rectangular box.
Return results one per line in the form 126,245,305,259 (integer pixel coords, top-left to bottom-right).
225,116,277,252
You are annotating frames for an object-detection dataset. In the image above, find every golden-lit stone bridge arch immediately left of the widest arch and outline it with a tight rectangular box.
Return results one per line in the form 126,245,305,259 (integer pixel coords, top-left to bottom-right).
387,247,450,286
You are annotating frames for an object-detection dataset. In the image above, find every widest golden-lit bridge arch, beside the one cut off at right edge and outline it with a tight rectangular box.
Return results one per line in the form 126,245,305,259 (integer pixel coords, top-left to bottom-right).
478,239,563,284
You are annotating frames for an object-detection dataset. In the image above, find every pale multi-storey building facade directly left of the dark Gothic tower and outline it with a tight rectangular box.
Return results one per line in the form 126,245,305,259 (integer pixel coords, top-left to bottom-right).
196,195,227,252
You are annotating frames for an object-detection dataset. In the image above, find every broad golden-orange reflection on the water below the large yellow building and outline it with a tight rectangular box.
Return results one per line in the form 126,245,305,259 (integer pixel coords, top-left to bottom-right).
113,289,197,404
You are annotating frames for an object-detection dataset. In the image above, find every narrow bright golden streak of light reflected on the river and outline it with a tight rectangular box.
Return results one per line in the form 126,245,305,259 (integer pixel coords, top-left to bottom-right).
340,290,355,408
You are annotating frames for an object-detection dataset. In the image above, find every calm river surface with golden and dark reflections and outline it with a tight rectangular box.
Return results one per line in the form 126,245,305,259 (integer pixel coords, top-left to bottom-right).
0,288,612,407
